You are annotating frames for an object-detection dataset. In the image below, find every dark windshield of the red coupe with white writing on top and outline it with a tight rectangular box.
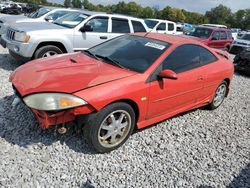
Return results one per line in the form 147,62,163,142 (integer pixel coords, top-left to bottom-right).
88,35,170,73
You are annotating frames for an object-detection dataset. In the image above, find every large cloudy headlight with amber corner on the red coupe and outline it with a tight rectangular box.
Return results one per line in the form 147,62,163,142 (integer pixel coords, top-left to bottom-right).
23,93,88,111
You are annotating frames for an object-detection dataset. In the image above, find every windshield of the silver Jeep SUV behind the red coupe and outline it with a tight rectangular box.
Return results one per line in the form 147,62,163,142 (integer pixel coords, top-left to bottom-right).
54,12,88,28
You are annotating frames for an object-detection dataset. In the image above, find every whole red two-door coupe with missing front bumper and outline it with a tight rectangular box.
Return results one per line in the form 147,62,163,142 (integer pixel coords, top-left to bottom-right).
10,33,234,153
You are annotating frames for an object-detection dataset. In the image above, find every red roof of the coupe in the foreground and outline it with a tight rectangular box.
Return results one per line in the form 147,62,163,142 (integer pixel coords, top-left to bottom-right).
132,32,203,46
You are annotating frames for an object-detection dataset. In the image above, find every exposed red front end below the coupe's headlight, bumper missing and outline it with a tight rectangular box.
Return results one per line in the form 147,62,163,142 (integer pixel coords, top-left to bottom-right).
31,106,95,132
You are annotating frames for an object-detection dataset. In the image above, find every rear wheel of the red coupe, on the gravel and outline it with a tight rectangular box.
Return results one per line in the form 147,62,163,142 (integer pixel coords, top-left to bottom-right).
208,81,228,110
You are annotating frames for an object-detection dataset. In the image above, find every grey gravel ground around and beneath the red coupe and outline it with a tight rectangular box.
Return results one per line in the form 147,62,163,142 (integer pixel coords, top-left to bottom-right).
0,45,250,188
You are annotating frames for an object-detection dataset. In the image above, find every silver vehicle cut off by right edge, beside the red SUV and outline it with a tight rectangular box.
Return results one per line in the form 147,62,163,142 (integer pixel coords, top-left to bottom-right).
229,32,250,54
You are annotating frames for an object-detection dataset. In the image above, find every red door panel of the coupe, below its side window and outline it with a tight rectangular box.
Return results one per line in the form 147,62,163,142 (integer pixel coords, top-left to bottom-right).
147,68,203,119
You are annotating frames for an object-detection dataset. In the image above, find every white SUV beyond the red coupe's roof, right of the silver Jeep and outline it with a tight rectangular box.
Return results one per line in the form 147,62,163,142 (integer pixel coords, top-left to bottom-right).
144,19,176,35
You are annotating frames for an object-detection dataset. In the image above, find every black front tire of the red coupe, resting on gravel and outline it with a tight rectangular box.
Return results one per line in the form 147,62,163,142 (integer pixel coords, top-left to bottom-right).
83,102,135,153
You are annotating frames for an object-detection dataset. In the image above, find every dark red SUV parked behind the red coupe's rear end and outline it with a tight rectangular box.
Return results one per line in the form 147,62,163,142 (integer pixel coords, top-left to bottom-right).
189,26,233,50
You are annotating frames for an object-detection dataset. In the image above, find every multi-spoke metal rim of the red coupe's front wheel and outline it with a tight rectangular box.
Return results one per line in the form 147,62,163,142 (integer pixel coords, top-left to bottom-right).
98,110,131,148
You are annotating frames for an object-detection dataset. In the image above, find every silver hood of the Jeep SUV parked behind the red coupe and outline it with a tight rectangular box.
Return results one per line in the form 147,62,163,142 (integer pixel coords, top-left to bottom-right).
10,22,65,32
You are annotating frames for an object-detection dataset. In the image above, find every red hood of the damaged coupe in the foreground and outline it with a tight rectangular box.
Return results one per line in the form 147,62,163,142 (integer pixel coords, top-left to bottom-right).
10,52,136,96
